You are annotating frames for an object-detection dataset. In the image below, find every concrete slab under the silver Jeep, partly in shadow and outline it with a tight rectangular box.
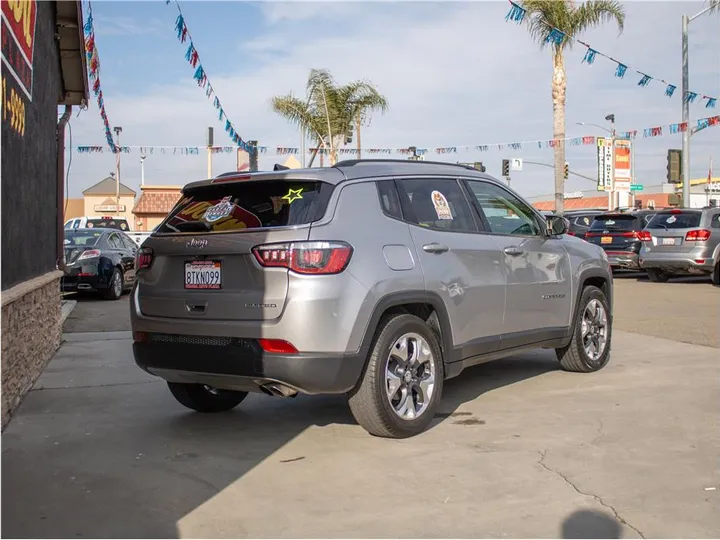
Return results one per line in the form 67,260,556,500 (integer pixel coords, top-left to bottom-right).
2,332,720,538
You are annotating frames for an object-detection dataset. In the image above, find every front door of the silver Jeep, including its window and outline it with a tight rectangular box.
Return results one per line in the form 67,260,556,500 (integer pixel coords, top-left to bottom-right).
466,180,572,338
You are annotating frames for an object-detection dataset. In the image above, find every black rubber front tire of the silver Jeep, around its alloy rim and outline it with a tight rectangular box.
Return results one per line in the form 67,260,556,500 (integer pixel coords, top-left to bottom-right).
555,285,612,373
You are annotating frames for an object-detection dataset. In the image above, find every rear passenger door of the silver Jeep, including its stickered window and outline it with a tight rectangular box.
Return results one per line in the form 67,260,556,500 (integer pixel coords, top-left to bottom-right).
397,178,505,359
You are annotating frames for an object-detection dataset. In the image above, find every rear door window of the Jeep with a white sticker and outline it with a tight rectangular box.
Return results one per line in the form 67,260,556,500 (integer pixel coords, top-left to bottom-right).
398,178,477,232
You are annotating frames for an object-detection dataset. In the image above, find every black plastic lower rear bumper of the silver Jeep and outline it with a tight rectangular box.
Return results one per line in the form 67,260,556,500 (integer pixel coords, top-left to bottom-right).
133,335,365,395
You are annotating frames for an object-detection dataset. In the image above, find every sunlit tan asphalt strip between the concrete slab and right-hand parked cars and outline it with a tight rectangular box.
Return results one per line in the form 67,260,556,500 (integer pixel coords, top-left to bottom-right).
614,273,720,347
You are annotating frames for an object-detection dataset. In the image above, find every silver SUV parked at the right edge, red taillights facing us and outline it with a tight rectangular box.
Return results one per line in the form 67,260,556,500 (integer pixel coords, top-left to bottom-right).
639,207,720,285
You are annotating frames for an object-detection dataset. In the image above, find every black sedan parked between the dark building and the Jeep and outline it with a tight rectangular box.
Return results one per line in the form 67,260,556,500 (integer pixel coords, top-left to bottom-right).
62,228,138,300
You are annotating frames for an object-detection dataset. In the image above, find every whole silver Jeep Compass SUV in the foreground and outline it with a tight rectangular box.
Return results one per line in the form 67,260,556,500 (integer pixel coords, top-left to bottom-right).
130,160,613,438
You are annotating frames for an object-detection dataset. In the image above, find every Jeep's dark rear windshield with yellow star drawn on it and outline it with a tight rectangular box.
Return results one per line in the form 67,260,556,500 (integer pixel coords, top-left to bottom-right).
157,180,333,234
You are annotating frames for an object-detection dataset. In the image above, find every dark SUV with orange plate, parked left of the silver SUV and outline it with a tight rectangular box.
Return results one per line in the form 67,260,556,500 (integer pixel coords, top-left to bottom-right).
585,210,656,270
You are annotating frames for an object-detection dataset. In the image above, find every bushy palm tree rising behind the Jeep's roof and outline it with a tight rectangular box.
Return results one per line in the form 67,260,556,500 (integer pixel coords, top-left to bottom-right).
272,69,388,166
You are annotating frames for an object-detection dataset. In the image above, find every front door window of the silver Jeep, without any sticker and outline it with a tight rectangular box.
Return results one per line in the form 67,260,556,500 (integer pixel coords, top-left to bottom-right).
467,180,543,236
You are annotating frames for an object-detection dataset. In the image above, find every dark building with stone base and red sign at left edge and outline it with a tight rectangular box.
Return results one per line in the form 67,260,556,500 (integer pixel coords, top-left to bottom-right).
0,0,88,428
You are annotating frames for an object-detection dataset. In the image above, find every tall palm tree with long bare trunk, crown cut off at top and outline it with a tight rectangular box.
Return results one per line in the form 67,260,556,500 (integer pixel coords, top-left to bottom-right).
519,0,624,214
